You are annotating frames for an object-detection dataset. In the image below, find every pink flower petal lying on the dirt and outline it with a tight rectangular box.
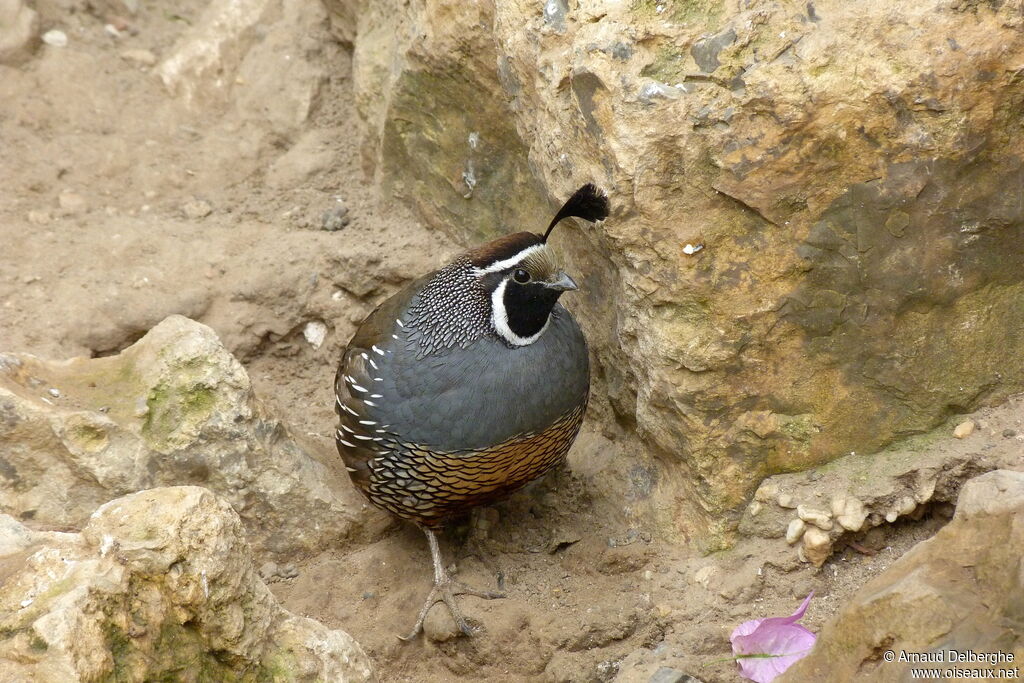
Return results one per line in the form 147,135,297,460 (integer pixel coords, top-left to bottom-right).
729,591,816,683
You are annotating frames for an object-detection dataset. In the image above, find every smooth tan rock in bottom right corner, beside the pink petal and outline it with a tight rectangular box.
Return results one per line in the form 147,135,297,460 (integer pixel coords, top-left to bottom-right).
779,470,1024,681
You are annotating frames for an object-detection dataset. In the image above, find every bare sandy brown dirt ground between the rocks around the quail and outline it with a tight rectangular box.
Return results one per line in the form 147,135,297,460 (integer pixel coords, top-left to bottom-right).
0,0,1020,681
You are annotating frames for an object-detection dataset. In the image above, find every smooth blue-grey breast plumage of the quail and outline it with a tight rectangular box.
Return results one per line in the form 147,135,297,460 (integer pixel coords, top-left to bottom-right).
354,305,590,451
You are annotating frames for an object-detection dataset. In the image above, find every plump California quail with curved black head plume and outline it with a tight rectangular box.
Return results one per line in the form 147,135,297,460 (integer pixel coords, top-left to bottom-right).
335,184,608,639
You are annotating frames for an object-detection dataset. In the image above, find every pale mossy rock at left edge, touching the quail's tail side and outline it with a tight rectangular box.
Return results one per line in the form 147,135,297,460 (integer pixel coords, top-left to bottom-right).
0,315,384,553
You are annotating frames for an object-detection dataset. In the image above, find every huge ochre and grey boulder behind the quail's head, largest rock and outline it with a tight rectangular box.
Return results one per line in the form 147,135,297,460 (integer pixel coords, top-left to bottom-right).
328,0,1024,548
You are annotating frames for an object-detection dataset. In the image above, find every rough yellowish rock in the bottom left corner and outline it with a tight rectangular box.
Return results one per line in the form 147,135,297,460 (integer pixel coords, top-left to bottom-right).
0,486,373,683
